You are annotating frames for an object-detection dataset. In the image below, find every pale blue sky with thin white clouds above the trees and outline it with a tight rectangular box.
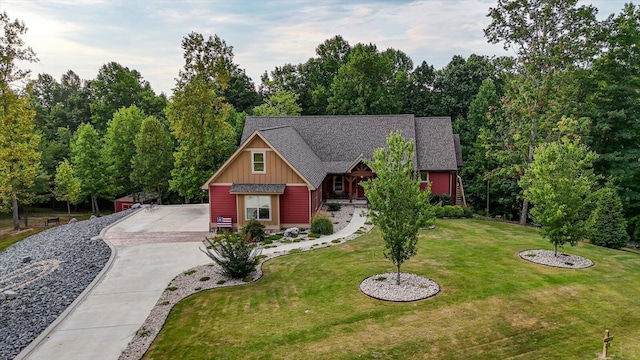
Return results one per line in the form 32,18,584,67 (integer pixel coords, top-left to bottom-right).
0,0,628,95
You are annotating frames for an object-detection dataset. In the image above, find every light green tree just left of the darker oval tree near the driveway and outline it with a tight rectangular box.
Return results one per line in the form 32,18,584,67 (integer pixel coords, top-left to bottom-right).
103,105,146,196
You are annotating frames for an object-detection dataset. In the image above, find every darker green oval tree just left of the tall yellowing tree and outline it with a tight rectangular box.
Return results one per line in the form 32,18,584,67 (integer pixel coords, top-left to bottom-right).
131,116,173,204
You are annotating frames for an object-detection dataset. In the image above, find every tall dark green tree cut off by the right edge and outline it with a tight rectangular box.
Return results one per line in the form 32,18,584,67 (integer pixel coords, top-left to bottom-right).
582,3,640,228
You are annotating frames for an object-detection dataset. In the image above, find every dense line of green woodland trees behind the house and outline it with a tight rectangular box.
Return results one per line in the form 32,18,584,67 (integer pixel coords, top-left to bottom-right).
0,0,640,243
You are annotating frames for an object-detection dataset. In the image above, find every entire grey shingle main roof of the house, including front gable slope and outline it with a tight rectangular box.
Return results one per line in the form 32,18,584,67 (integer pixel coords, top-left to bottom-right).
242,115,458,186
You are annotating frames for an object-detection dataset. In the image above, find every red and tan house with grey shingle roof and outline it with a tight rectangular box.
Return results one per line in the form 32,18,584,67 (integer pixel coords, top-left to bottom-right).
202,115,462,231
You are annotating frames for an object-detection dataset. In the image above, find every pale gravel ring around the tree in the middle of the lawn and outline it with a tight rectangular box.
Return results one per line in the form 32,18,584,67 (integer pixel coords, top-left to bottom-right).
360,272,440,302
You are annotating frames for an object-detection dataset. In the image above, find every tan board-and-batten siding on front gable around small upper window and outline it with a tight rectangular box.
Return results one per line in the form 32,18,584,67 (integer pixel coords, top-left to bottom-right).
215,136,305,184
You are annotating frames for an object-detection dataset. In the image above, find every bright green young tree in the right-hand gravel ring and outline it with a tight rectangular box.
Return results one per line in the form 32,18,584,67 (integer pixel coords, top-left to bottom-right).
520,137,597,256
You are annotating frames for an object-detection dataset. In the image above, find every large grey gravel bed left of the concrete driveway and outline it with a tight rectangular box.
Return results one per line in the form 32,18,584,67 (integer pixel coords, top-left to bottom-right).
0,210,133,359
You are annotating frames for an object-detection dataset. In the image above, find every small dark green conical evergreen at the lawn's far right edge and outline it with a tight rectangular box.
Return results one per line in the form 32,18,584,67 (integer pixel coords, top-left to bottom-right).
590,186,629,249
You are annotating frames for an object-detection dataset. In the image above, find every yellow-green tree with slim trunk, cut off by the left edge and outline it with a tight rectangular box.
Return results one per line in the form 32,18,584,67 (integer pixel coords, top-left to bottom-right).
0,87,41,230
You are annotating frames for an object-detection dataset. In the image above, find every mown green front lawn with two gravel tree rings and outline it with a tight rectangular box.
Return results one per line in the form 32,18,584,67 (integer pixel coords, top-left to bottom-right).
145,220,640,359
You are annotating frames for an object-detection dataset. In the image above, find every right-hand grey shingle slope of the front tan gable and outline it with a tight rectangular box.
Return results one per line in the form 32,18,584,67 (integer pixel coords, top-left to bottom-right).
260,126,327,188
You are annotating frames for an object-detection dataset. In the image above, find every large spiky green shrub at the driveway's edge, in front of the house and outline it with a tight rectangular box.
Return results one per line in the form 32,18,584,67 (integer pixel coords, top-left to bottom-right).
200,234,262,279
